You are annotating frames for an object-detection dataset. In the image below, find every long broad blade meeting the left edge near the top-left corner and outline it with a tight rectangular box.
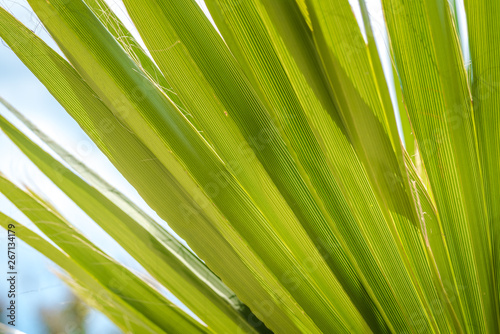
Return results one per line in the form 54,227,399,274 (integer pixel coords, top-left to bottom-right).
0,7,314,332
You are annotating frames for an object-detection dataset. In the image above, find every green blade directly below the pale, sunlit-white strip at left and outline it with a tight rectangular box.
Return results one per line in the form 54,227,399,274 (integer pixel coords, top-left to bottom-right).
0,103,258,332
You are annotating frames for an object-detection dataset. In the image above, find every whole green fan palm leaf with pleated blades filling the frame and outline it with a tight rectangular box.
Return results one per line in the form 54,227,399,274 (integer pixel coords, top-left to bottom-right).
0,0,500,333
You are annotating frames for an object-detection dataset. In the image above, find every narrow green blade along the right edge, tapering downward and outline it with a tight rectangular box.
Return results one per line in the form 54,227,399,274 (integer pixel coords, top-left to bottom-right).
462,1,500,324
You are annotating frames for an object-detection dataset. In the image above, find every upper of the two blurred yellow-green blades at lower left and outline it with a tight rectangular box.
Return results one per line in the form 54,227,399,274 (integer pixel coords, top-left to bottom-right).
0,177,208,333
